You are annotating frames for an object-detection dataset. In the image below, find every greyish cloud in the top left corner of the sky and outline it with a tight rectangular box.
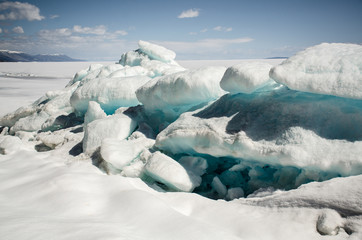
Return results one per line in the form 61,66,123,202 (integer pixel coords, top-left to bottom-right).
0,2,44,21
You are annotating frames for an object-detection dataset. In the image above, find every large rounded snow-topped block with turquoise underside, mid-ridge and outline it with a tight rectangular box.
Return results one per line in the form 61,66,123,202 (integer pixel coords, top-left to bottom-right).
136,67,226,118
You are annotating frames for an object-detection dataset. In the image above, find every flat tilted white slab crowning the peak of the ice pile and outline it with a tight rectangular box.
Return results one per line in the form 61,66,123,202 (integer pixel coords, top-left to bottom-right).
138,40,176,63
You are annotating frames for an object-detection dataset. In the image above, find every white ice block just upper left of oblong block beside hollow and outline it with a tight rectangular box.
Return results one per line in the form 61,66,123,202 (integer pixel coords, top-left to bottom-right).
101,137,155,170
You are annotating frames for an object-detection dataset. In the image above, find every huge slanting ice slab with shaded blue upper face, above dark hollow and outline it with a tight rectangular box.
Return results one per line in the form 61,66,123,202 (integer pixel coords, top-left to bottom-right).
155,89,362,175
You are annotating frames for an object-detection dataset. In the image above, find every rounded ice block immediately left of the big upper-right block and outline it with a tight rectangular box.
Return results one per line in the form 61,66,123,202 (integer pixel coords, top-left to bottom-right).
220,62,273,94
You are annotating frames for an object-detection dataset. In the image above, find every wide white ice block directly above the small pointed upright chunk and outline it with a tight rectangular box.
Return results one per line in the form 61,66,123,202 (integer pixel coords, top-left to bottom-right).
70,76,150,114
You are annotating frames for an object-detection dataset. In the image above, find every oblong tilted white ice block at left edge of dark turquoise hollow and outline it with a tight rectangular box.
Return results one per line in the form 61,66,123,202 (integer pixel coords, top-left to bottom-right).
145,152,200,192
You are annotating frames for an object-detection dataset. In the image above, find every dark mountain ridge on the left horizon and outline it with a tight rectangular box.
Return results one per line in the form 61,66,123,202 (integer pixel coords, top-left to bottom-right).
0,50,84,62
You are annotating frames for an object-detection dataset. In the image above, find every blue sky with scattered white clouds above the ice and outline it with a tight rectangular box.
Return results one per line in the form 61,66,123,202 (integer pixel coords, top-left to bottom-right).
0,0,362,61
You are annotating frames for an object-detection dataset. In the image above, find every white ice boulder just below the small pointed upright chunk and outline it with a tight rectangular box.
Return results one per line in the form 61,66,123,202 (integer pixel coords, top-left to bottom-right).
83,114,137,154
